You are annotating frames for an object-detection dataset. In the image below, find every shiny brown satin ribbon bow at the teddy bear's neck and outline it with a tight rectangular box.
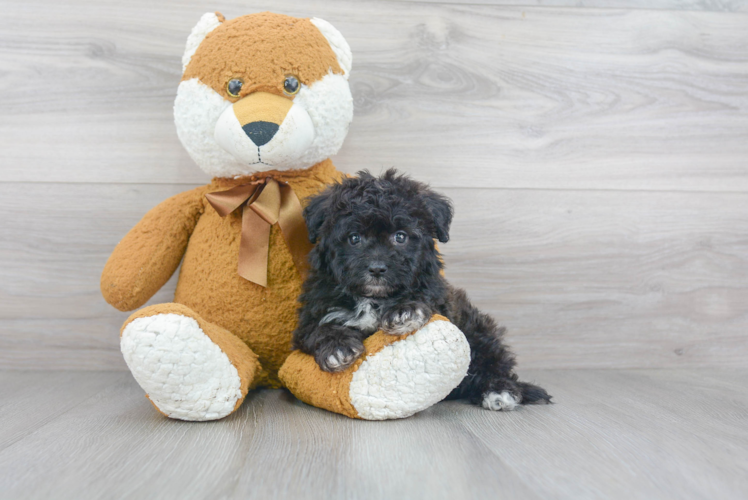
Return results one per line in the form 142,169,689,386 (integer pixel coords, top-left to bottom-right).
205,177,312,287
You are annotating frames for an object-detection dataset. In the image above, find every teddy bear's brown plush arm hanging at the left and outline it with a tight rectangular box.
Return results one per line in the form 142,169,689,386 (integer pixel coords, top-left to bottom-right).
101,187,206,311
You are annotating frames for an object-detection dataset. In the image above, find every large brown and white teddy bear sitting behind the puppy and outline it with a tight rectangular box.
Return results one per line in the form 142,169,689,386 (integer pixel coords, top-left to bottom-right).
101,12,470,421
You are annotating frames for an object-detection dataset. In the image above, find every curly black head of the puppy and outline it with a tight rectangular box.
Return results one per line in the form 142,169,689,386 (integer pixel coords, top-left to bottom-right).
304,169,452,297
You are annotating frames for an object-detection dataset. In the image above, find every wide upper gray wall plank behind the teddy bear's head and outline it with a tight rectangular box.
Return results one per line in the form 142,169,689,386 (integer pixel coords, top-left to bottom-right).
0,0,748,191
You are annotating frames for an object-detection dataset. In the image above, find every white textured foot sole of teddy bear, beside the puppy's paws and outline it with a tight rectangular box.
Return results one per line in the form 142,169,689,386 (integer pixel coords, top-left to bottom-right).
350,321,470,420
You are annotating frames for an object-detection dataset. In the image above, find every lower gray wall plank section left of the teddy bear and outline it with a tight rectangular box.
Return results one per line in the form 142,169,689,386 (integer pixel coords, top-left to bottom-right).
0,183,180,370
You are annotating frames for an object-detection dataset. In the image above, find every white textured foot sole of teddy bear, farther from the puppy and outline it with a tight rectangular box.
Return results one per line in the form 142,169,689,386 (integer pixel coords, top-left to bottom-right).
120,314,242,420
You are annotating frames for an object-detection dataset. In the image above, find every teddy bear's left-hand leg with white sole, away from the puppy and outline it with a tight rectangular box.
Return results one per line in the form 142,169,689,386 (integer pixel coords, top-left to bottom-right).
120,304,260,420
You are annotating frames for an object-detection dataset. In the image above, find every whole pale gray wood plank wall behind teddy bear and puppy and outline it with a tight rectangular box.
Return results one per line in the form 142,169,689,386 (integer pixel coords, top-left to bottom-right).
0,0,748,369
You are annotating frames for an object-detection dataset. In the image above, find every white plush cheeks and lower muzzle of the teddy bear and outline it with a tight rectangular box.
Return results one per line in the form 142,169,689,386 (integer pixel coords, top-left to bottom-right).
174,73,353,177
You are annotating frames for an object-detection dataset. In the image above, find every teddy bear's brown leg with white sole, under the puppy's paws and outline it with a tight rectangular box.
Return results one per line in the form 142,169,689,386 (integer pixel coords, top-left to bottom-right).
279,315,470,420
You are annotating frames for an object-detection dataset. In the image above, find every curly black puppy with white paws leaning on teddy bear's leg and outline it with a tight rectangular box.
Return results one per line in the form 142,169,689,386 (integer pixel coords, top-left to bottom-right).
293,169,551,410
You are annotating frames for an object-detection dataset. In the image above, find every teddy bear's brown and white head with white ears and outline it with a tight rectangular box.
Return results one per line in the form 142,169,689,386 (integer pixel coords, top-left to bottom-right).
174,12,353,177
